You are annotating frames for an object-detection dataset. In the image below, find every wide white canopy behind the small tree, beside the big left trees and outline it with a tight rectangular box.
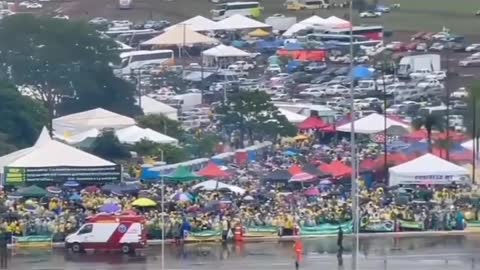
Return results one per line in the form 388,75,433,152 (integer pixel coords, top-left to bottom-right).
53,108,135,137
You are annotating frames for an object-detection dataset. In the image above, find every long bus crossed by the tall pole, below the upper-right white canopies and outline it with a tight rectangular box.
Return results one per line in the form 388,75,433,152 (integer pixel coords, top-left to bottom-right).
299,33,379,46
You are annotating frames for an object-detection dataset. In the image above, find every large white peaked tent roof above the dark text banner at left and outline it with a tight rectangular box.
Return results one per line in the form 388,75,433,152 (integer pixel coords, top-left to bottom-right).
0,128,115,173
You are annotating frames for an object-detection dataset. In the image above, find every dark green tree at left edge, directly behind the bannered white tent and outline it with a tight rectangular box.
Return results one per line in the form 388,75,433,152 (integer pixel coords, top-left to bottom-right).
0,82,47,148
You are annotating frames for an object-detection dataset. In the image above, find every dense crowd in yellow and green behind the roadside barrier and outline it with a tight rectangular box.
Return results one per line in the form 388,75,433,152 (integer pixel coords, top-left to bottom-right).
0,139,480,241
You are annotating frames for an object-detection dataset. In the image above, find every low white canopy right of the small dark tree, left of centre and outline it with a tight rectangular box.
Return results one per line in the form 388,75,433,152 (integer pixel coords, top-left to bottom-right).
115,126,178,144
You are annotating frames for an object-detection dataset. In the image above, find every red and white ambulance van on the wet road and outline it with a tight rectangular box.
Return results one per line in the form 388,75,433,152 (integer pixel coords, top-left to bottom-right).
65,214,147,254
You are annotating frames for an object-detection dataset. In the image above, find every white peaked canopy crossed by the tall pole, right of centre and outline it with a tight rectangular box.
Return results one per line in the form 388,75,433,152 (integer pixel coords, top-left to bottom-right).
337,113,409,134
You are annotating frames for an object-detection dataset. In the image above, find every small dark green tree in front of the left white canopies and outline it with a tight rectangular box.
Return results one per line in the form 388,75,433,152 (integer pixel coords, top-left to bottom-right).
92,130,130,160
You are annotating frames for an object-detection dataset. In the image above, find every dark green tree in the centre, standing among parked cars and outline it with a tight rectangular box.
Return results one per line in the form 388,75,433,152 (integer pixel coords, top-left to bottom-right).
217,91,295,147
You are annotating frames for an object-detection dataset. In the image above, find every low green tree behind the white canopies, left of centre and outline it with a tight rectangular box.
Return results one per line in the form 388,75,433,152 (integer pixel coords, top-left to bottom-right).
137,114,185,140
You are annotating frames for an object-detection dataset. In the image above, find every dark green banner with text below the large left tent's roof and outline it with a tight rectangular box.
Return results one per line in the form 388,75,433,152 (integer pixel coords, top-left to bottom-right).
3,165,122,185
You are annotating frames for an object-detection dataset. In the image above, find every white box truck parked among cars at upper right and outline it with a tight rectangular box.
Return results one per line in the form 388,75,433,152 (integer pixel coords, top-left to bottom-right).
397,54,441,79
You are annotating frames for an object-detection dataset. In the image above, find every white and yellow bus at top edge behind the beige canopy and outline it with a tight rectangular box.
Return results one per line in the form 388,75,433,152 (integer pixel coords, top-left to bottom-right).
211,2,263,21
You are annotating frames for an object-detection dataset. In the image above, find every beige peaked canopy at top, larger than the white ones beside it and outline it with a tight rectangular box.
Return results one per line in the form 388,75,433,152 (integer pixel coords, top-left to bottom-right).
142,25,218,46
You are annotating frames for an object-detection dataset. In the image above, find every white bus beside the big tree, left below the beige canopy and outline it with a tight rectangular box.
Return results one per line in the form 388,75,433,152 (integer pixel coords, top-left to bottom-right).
117,50,175,75
